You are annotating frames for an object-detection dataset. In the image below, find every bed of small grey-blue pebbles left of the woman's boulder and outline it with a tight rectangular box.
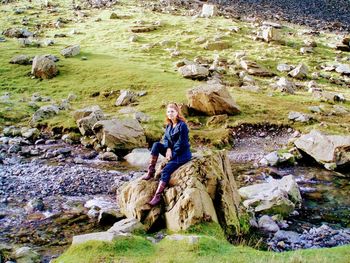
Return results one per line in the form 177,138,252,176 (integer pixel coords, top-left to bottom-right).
0,162,120,198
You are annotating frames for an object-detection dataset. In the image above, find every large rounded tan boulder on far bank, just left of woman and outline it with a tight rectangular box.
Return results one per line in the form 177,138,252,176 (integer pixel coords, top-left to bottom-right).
92,119,146,150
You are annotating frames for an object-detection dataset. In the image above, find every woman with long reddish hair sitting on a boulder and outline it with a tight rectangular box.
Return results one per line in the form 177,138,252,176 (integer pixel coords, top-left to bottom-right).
142,103,192,206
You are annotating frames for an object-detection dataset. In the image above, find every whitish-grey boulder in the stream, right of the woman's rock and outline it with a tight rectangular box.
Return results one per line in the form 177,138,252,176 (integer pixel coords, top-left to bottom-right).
238,175,301,216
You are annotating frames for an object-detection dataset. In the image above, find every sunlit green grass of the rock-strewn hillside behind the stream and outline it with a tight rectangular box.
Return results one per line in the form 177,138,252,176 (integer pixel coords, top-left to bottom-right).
0,0,350,140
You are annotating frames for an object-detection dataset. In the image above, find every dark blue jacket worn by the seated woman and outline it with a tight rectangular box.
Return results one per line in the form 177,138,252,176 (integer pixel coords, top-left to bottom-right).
163,120,192,162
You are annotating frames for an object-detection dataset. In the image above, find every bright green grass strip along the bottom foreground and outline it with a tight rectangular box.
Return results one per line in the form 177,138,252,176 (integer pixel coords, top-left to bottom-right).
54,233,350,263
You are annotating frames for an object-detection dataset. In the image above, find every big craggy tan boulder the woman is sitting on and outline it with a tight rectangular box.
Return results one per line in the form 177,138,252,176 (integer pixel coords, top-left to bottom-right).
118,152,242,235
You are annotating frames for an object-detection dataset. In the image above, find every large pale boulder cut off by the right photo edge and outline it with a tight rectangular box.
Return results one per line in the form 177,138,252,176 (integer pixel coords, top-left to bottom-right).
294,130,350,170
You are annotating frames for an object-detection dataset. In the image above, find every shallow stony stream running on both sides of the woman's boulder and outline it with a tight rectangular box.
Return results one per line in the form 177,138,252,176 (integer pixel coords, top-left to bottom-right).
0,126,350,262
